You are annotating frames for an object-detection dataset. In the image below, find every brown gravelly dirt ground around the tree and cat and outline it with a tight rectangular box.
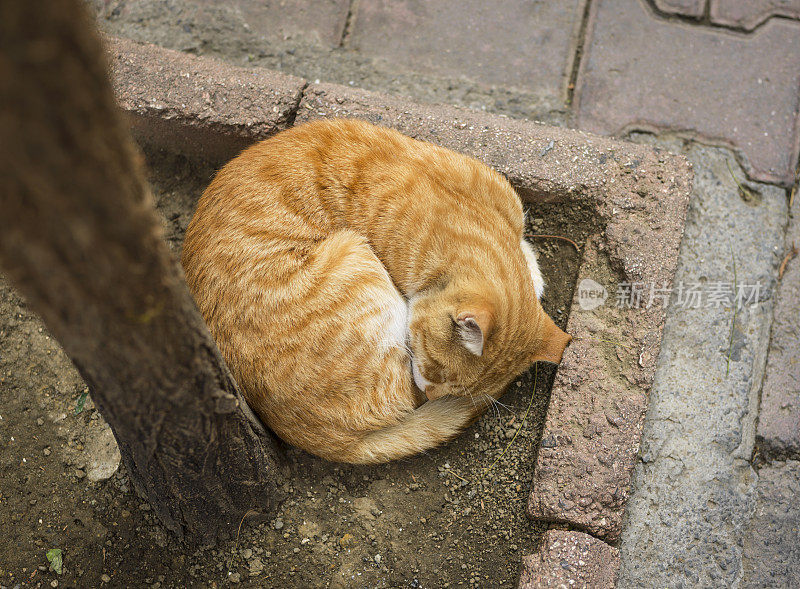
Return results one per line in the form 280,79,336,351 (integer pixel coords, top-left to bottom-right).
0,144,587,587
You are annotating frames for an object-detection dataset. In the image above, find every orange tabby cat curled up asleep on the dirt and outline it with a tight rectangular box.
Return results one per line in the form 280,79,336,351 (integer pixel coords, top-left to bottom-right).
182,120,570,463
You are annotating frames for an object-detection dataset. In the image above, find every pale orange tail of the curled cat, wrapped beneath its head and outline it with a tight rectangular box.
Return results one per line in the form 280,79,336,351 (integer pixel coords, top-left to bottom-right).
347,396,487,464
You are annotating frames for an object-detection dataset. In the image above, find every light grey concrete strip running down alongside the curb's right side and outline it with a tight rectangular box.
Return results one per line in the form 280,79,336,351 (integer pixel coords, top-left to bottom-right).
618,135,787,588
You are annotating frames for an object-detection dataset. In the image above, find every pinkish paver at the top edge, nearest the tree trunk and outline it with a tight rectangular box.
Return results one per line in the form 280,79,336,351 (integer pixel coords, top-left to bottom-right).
89,0,350,51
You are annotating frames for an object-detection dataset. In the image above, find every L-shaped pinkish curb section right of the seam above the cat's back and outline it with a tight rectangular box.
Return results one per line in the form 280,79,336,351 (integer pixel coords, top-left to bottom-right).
297,84,691,540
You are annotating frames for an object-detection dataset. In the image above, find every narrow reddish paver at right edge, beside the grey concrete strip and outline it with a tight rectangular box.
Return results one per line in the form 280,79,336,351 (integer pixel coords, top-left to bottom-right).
756,198,800,458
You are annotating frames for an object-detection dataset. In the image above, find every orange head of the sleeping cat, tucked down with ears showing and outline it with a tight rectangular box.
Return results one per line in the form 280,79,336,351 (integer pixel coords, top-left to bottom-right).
408,282,571,400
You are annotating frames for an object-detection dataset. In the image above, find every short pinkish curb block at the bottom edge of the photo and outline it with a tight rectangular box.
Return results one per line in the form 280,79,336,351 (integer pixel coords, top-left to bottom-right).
519,530,619,589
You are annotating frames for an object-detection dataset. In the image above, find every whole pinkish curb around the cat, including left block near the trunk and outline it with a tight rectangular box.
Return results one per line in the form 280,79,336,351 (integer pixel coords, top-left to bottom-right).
107,39,692,584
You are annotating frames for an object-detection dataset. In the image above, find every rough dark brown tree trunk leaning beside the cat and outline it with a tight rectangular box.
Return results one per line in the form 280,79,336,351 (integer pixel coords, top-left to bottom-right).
0,0,286,543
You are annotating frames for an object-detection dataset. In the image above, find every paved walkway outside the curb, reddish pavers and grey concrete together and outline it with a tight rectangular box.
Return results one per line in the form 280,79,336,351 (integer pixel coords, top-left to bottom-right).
87,0,800,587
